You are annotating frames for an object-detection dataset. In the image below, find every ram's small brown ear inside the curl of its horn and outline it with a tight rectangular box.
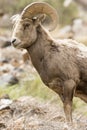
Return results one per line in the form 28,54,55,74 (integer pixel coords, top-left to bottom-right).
32,14,46,25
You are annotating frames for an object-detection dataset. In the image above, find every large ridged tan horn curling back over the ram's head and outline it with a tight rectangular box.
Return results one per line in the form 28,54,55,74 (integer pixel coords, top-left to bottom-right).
21,2,58,31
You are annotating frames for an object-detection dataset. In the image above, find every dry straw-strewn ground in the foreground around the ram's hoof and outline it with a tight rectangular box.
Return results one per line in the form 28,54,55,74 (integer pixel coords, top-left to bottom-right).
0,96,87,130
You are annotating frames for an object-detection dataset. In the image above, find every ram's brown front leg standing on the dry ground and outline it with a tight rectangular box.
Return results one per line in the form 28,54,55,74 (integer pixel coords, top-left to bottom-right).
63,80,76,122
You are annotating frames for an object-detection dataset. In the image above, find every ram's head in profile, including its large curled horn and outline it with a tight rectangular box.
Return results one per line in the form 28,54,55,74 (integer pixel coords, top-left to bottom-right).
12,2,58,48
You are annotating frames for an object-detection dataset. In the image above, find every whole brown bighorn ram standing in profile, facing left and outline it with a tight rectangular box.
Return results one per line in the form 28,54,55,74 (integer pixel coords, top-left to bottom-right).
12,2,87,122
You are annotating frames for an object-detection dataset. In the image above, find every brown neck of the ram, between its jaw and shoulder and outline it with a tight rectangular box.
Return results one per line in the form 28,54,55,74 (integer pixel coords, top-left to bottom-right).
28,26,52,73
